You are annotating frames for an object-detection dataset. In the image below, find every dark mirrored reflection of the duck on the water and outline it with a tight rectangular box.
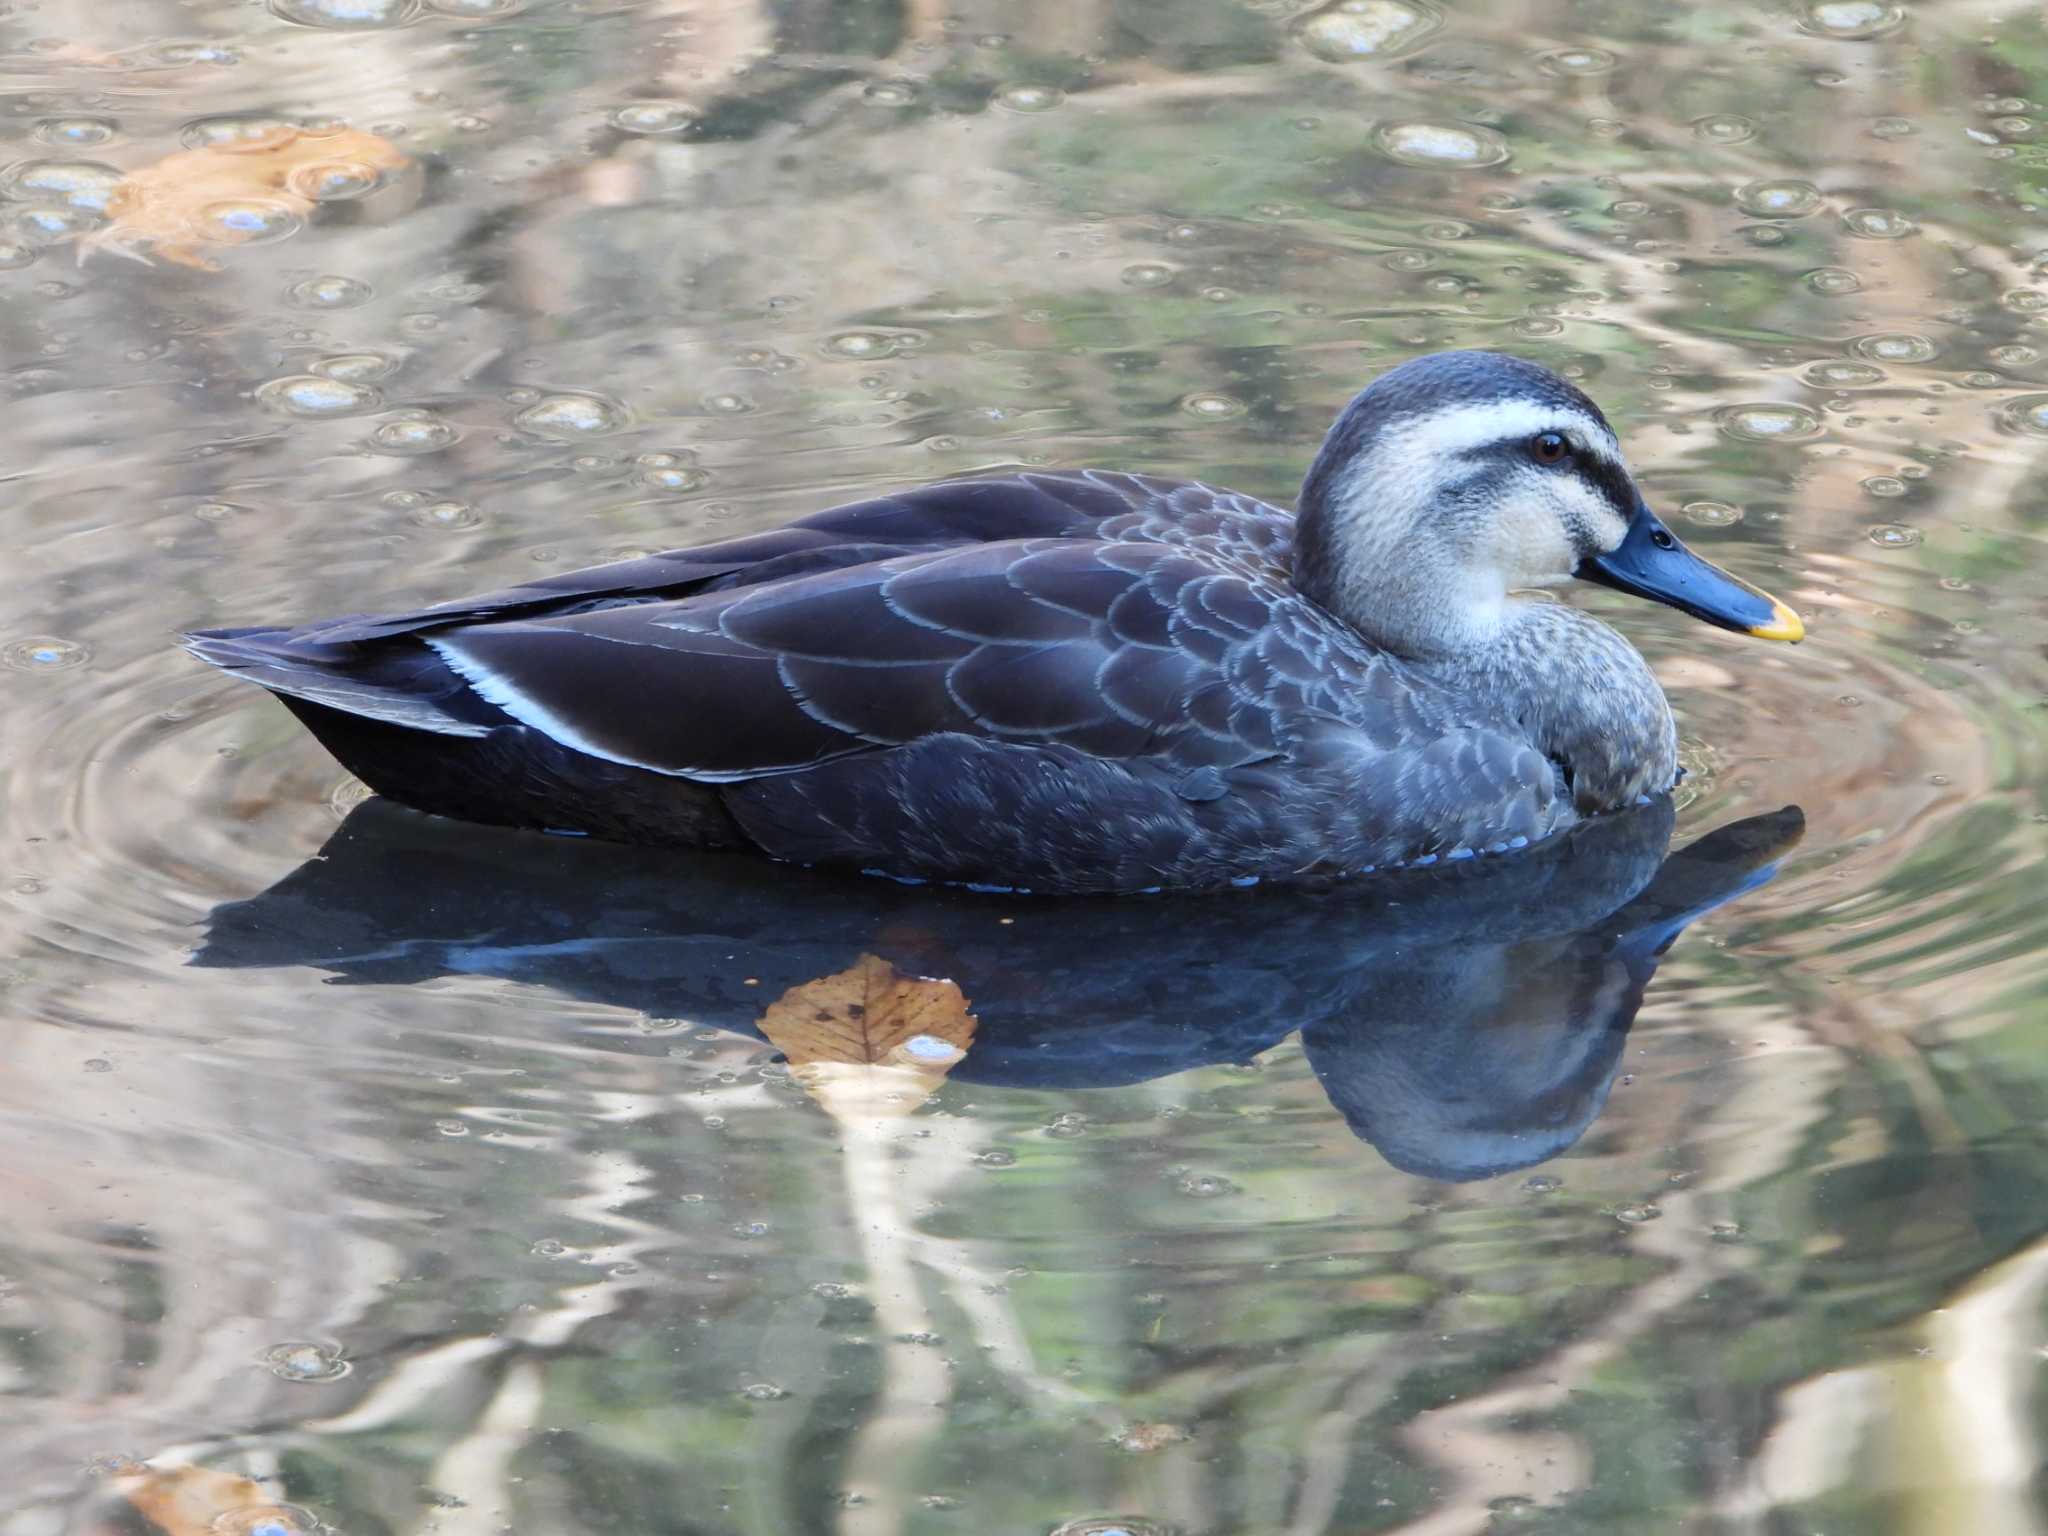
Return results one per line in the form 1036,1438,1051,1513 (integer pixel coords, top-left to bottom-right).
195,799,1804,1180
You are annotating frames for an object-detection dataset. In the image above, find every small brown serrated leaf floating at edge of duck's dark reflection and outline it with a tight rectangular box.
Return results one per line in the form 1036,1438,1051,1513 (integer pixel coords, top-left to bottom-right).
760,954,975,1120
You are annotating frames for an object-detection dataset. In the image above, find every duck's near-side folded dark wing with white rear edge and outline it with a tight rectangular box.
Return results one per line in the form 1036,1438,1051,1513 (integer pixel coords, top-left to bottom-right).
426,539,1310,793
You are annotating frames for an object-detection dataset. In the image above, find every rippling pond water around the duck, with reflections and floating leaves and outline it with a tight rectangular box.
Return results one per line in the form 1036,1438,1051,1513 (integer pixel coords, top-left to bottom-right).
0,0,2048,1536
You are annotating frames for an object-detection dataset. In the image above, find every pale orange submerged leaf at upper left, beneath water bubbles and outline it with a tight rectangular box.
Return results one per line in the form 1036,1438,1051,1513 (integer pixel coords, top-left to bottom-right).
78,123,412,272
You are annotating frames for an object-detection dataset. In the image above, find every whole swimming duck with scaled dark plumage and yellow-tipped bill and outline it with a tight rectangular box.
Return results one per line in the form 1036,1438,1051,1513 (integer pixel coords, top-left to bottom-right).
184,350,1804,893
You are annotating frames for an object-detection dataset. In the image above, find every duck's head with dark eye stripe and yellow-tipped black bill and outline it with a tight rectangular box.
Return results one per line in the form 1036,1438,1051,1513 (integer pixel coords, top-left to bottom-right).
1294,352,1806,657
